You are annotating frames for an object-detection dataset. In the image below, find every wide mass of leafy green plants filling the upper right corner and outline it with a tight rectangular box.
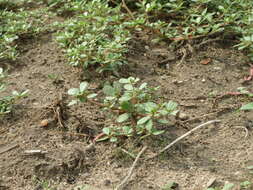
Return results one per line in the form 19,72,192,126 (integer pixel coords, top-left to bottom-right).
118,0,253,60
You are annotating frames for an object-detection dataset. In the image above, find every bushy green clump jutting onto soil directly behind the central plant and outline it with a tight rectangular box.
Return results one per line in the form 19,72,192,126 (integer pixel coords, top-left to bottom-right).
56,0,130,72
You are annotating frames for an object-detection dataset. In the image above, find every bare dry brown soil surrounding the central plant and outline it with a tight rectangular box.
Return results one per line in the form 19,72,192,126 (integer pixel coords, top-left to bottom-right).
0,20,253,190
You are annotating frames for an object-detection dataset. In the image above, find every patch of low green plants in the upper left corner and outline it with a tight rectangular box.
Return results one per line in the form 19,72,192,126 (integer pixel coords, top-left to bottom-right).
0,6,52,60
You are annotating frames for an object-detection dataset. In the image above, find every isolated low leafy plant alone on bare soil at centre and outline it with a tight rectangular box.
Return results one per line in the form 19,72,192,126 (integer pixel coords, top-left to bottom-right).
68,77,177,142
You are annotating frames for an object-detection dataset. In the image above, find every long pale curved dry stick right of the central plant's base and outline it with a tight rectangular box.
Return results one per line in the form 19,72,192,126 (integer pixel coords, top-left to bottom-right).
148,120,221,159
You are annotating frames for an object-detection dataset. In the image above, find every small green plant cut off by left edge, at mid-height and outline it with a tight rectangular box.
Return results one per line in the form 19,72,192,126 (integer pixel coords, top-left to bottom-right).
0,68,28,116
